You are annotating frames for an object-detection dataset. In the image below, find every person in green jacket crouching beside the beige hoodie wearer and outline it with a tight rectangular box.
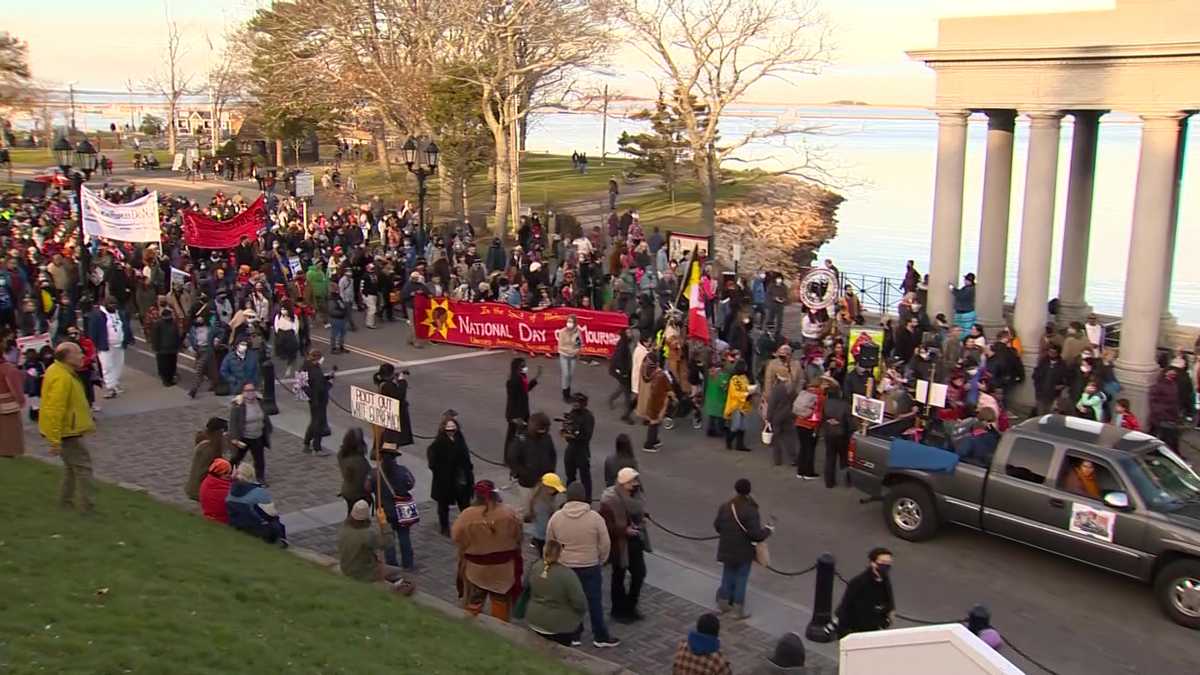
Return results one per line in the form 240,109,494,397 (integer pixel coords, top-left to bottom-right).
526,540,588,647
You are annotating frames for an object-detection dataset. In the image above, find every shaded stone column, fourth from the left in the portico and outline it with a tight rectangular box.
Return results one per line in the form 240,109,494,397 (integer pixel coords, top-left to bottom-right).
1058,110,1102,323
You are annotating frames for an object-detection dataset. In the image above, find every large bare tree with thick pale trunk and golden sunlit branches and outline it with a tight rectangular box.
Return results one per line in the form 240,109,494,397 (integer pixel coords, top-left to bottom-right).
444,0,608,233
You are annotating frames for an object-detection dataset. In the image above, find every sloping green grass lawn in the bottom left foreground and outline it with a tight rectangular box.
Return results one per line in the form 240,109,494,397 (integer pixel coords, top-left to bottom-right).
0,459,569,675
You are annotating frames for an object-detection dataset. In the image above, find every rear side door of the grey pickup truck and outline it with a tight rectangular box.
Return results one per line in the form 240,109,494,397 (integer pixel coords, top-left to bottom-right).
983,436,1062,550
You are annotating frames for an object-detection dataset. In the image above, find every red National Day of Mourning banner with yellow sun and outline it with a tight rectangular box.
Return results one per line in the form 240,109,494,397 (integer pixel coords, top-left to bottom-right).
413,295,629,358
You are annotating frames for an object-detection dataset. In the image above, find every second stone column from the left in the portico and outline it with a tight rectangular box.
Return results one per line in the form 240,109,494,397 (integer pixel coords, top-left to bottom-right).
976,110,1016,335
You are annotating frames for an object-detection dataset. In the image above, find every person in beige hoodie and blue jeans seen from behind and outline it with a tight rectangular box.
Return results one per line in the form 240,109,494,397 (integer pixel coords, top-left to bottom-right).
546,482,620,647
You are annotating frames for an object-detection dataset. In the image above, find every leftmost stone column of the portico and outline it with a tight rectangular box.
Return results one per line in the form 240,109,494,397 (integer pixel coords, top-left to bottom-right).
926,110,971,319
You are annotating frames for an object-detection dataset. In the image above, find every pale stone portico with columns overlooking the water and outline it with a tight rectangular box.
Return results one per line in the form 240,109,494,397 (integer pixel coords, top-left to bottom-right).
908,0,1200,414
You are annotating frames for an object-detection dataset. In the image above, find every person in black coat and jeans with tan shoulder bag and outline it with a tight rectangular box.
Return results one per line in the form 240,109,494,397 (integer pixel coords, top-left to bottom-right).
713,478,774,619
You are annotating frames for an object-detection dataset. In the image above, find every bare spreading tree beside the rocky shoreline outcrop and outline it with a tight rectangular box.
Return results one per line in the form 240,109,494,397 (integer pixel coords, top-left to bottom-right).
616,0,830,234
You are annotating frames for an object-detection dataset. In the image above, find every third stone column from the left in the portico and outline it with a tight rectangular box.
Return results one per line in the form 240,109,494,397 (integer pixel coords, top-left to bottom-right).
1013,110,1062,372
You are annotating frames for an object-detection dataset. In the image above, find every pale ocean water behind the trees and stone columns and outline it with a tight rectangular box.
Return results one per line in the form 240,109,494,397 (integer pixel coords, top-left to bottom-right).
28,94,1200,324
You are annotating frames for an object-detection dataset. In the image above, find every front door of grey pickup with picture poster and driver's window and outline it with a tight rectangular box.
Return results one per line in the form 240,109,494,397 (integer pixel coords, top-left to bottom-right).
1045,449,1150,577
